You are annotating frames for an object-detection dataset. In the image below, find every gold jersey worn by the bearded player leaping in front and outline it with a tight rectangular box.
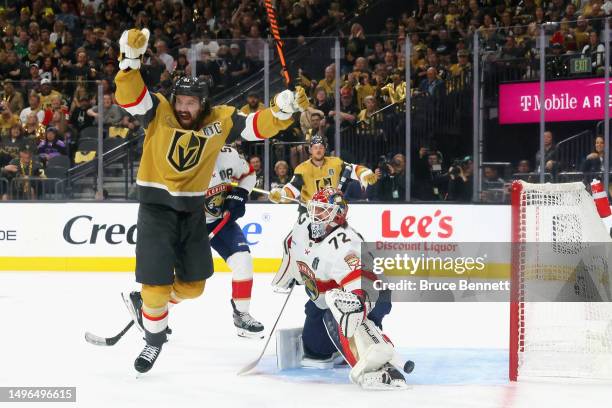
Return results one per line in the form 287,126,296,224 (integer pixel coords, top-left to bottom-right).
115,70,292,212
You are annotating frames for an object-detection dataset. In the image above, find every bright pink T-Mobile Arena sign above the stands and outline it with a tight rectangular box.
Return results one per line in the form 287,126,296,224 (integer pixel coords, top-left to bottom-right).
499,78,612,125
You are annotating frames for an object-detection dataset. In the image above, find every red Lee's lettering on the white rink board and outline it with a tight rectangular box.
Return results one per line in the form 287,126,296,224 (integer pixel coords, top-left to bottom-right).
382,210,453,238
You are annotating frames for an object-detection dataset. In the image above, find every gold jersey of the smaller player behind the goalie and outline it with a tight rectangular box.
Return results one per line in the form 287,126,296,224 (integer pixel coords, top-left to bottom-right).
283,156,372,203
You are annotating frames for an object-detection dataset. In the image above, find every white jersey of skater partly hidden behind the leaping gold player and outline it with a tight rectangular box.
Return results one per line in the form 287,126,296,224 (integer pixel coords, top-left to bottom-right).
204,146,256,224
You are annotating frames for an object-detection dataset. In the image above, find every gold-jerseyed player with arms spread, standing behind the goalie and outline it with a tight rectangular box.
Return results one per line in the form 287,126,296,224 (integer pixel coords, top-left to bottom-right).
268,135,378,285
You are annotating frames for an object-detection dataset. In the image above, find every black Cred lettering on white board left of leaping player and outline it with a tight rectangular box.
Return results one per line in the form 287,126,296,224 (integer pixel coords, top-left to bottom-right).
63,215,136,245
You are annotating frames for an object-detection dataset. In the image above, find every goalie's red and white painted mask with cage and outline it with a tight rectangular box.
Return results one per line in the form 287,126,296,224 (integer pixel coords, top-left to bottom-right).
307,187,348,239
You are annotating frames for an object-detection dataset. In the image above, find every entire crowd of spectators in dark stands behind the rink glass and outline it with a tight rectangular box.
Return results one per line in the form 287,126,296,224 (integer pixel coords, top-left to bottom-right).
0,0,612,201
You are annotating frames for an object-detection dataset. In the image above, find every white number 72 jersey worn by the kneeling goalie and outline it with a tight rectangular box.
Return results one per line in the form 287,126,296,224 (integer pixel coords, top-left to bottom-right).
291,214,377,309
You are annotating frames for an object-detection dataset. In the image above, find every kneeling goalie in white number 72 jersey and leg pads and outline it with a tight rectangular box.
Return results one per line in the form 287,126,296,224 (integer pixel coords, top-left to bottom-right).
278,188,406,389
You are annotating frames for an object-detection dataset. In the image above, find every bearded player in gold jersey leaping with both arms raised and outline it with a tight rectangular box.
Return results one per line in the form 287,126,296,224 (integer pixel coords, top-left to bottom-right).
115,29,308,372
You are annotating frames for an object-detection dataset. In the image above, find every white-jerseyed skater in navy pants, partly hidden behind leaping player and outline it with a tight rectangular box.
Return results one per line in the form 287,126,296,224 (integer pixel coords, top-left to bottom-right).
204,146,264,338
